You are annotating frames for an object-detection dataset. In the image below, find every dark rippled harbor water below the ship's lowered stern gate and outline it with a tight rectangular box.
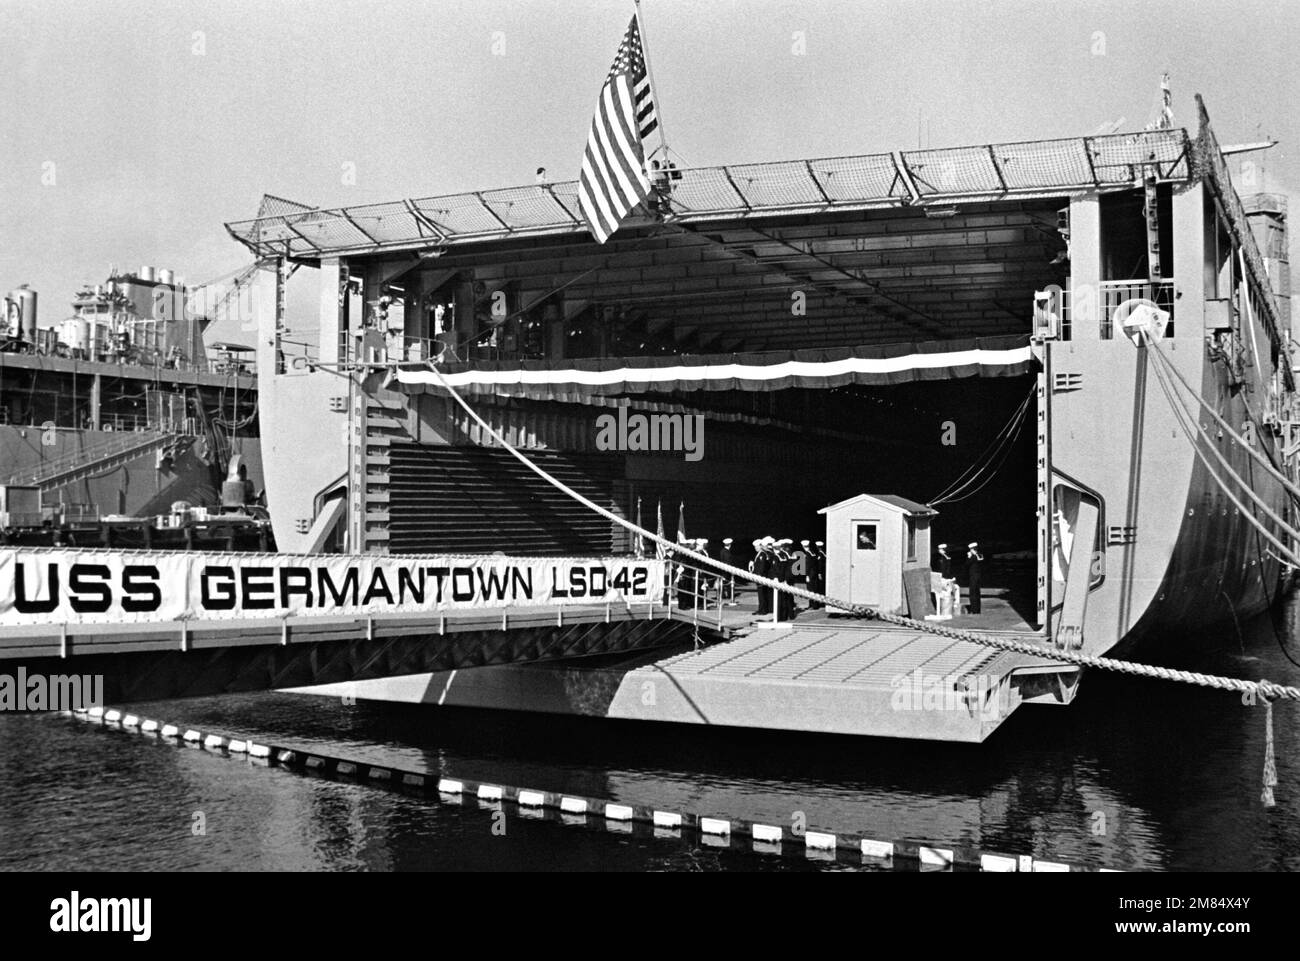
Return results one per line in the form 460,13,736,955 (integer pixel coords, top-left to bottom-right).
0,603,1300,870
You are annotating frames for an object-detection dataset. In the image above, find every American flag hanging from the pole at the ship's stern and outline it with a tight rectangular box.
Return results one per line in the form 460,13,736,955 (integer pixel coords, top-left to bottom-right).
577,14,659,243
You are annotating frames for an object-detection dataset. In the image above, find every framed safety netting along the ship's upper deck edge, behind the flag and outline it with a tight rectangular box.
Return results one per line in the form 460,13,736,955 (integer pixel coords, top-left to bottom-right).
226,130,1191,259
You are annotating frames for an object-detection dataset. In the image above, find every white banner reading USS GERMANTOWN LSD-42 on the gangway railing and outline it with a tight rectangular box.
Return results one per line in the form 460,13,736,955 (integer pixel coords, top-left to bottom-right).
0,547,664,628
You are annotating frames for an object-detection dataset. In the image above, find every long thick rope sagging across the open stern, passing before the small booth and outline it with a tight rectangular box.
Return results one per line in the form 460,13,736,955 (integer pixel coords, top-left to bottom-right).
416,364,1300,701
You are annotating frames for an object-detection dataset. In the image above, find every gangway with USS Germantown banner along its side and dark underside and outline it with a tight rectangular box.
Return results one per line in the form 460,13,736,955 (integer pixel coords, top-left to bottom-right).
0,547,723,701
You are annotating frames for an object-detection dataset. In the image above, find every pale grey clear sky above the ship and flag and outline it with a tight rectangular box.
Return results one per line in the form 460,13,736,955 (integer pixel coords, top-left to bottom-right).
0,0,1300,345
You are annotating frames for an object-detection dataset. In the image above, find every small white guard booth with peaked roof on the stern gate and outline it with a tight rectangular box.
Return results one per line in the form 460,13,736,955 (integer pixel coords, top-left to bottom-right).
818,494,939,618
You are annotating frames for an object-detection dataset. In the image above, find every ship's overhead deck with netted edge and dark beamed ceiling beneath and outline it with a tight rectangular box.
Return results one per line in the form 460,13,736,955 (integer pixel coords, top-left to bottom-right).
228,130,1191,354
